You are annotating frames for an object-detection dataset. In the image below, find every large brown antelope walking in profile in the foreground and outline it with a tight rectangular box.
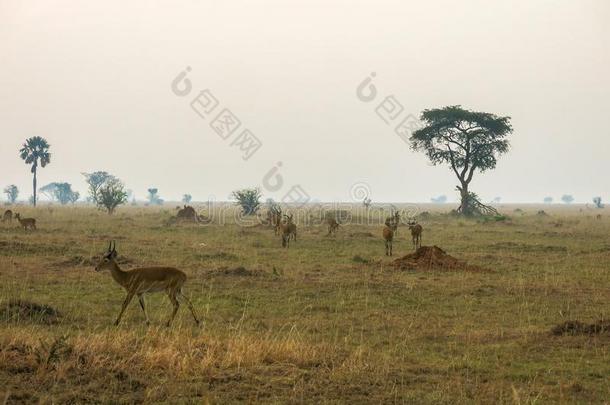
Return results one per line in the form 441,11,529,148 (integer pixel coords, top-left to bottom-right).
95,242,199,327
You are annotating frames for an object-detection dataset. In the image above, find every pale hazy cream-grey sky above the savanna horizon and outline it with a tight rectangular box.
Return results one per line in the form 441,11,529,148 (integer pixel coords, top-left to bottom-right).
0,0,610,202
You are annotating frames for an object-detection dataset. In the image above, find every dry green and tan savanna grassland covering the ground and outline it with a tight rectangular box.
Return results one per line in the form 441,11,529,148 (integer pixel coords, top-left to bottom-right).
0,207,610,404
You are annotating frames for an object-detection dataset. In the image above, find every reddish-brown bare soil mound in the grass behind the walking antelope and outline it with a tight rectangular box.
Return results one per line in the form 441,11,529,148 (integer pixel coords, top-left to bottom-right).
394,246,484,271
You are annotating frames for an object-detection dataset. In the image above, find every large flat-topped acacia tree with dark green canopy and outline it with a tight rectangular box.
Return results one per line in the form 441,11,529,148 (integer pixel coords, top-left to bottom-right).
410,105,513,216
